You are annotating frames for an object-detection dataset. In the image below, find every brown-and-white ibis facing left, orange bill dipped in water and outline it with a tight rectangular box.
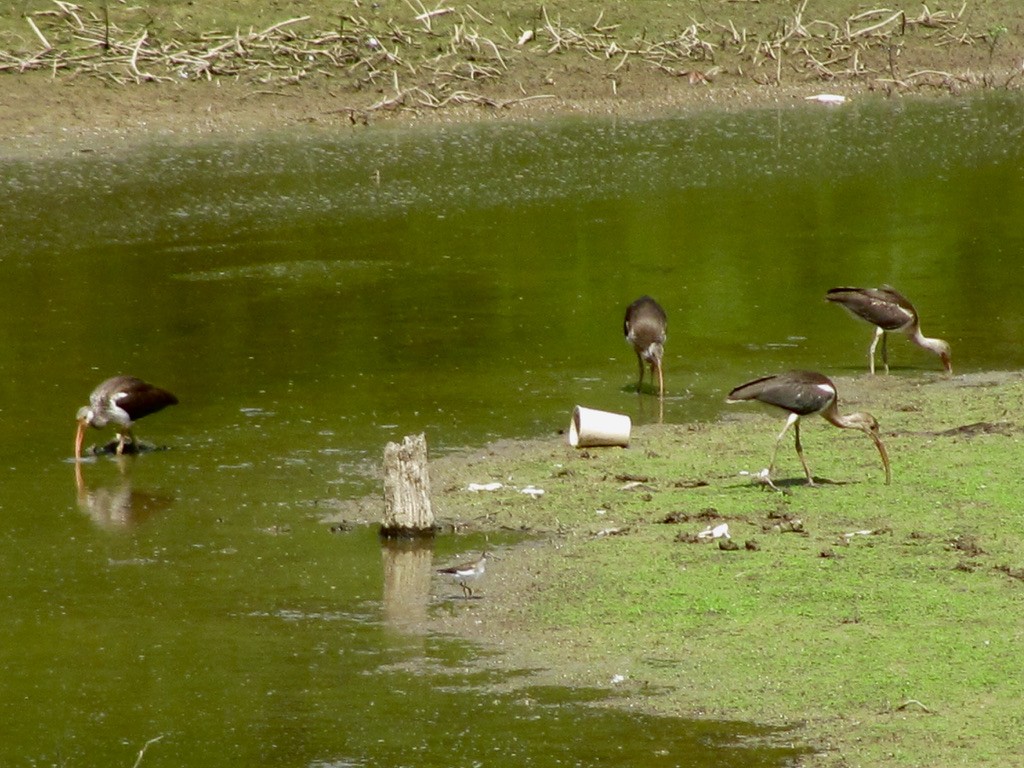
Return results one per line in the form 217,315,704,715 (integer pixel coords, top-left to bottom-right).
75,376,178,461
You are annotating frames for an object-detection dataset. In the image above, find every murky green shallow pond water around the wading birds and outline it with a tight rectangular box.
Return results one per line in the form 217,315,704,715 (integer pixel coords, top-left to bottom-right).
0,96,1024,766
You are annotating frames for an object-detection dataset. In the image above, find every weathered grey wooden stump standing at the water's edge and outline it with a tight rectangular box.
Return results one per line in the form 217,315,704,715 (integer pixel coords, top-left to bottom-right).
381,433,434,538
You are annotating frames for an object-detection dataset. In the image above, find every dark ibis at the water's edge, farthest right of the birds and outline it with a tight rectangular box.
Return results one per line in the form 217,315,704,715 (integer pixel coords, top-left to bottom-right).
825,286,953,374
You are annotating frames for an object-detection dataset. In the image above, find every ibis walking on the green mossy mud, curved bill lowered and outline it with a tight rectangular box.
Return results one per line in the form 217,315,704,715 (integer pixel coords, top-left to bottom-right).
726,371,892,485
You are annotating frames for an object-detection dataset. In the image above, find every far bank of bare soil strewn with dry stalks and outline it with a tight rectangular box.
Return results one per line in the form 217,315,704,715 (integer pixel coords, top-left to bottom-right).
0,0,1024,153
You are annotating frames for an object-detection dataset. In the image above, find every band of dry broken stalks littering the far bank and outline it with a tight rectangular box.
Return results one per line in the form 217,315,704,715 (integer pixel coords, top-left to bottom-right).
0,0,1022,118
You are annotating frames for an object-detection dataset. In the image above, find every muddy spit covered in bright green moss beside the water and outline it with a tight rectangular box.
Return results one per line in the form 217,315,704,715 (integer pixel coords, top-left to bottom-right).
425,374,1024,766
